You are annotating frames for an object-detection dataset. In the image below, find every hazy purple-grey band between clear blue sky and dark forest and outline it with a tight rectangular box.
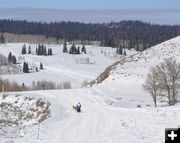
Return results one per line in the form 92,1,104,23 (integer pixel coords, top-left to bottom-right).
0,8,180,25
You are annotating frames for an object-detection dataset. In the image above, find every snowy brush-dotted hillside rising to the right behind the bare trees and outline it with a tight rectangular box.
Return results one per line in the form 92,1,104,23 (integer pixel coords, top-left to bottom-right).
90,37,180,107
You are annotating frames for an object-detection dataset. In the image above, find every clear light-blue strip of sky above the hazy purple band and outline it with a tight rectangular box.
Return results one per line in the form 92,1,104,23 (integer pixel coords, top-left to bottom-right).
0,0,180,9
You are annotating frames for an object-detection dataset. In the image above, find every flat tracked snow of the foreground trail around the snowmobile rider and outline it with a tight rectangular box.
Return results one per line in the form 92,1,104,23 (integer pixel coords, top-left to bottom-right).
9,89,180,143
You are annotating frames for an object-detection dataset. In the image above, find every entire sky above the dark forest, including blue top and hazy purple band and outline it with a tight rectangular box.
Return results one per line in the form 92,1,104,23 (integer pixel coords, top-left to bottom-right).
0,0,180,25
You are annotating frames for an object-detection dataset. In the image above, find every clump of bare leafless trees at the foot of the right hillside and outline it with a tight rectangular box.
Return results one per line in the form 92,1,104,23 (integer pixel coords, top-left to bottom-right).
143,58,180,106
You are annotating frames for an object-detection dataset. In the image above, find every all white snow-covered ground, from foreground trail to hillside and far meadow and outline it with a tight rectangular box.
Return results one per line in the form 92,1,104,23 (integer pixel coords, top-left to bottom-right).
0,37,180,143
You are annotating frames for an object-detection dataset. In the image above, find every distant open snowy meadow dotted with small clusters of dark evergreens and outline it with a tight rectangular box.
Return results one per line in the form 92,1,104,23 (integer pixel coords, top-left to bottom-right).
0,43,118,88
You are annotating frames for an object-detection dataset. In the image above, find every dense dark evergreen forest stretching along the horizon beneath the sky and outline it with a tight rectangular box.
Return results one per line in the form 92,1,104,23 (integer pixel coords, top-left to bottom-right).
0,20,180,51
